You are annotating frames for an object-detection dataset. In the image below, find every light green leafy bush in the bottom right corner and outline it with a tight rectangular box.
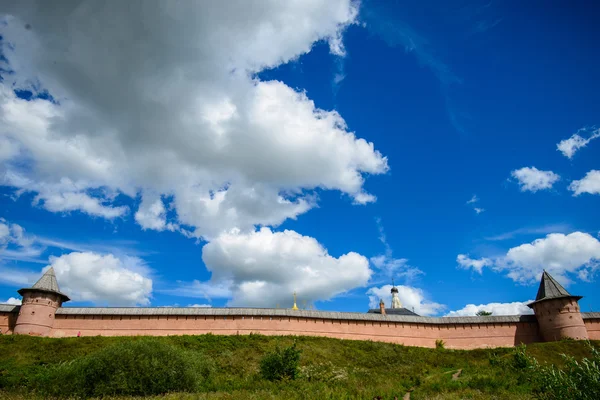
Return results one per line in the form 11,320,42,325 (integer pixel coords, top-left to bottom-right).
530,345,600,400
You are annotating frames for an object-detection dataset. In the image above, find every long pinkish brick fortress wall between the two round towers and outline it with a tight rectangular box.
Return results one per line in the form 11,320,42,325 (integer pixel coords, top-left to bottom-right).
50,314,540,349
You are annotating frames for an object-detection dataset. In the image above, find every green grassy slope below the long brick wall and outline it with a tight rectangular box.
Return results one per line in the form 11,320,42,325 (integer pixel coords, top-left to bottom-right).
0,335,600,400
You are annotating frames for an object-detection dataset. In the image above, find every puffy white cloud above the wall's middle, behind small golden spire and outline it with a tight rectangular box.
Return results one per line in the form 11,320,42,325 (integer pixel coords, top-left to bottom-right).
170,228,372,307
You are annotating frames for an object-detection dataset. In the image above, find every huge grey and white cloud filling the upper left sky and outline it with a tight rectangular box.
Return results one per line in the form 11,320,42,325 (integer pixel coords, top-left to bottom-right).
0,0,388,239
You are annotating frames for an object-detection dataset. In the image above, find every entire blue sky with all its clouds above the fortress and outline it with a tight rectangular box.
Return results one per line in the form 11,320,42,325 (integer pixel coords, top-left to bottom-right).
0,0,600,315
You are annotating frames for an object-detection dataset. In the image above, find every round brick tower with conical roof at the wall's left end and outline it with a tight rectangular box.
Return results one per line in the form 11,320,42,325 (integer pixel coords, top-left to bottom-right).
14,267,69,336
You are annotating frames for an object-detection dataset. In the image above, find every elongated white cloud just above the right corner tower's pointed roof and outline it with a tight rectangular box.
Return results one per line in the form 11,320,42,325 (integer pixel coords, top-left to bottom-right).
457,232,600,284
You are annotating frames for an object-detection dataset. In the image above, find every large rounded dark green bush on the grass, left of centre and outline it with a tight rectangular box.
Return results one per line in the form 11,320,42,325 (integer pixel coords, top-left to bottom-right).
40,339,211,398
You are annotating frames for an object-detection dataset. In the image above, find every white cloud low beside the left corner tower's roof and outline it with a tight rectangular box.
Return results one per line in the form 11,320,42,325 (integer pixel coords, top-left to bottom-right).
49,252,152,306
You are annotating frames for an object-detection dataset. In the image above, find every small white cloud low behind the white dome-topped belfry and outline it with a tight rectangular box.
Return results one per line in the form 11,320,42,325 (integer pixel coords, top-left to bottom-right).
367,285,446,316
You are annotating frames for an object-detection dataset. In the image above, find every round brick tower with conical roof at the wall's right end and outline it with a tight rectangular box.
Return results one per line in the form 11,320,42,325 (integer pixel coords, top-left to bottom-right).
527,271,588,342
